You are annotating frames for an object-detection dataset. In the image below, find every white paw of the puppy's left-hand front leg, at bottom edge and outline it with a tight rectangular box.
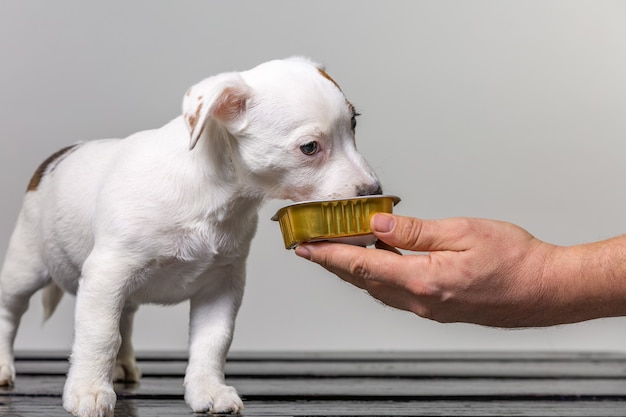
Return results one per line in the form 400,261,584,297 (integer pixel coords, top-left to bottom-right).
63,383,117,417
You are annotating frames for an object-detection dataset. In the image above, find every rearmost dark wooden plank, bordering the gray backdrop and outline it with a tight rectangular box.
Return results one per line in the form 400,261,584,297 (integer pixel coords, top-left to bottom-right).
16,353,626,379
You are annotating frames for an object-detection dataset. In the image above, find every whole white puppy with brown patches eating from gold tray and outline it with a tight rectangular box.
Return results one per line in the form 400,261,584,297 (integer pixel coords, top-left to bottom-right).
0,58,381,417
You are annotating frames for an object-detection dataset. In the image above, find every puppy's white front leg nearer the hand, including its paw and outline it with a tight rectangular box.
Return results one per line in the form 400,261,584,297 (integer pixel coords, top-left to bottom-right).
185,276,244,413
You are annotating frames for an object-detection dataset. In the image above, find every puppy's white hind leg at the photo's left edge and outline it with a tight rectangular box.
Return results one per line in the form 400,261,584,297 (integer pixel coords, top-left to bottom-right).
0,222,50,386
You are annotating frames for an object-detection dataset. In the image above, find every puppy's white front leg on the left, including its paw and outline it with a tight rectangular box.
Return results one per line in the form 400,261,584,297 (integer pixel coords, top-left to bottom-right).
63,254,130,417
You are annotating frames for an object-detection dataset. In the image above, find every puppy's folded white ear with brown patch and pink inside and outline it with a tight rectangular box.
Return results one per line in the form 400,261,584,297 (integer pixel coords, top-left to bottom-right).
183,72,251,150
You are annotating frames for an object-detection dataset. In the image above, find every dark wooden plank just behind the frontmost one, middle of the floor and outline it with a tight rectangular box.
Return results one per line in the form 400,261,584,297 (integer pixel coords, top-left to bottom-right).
7,376,626,401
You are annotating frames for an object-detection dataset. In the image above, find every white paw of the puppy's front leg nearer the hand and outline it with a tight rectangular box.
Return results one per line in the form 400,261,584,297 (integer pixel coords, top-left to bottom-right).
185,383,243,414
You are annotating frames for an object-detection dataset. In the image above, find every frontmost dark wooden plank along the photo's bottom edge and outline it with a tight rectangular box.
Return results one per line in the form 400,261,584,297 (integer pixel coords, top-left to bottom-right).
0,396,626,417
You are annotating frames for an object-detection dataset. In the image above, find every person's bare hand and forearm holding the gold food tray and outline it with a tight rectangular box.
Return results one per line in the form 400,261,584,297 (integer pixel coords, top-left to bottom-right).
296,214,626,328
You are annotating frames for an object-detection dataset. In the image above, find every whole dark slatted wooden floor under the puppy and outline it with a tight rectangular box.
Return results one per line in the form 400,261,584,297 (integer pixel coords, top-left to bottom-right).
0,353,626,417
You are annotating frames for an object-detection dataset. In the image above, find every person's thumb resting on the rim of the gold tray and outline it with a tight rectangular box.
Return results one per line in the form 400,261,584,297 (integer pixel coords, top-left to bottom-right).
370,213,462,252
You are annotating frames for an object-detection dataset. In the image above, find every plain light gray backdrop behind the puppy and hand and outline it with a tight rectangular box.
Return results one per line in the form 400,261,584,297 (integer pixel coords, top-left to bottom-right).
0,0,626,350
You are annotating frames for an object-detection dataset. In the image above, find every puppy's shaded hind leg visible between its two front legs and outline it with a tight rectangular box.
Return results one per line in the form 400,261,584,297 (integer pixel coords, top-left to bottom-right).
113,303,141,382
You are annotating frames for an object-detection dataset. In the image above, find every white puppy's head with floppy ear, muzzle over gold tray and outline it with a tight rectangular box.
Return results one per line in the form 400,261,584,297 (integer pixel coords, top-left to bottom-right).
183,58,382,201
